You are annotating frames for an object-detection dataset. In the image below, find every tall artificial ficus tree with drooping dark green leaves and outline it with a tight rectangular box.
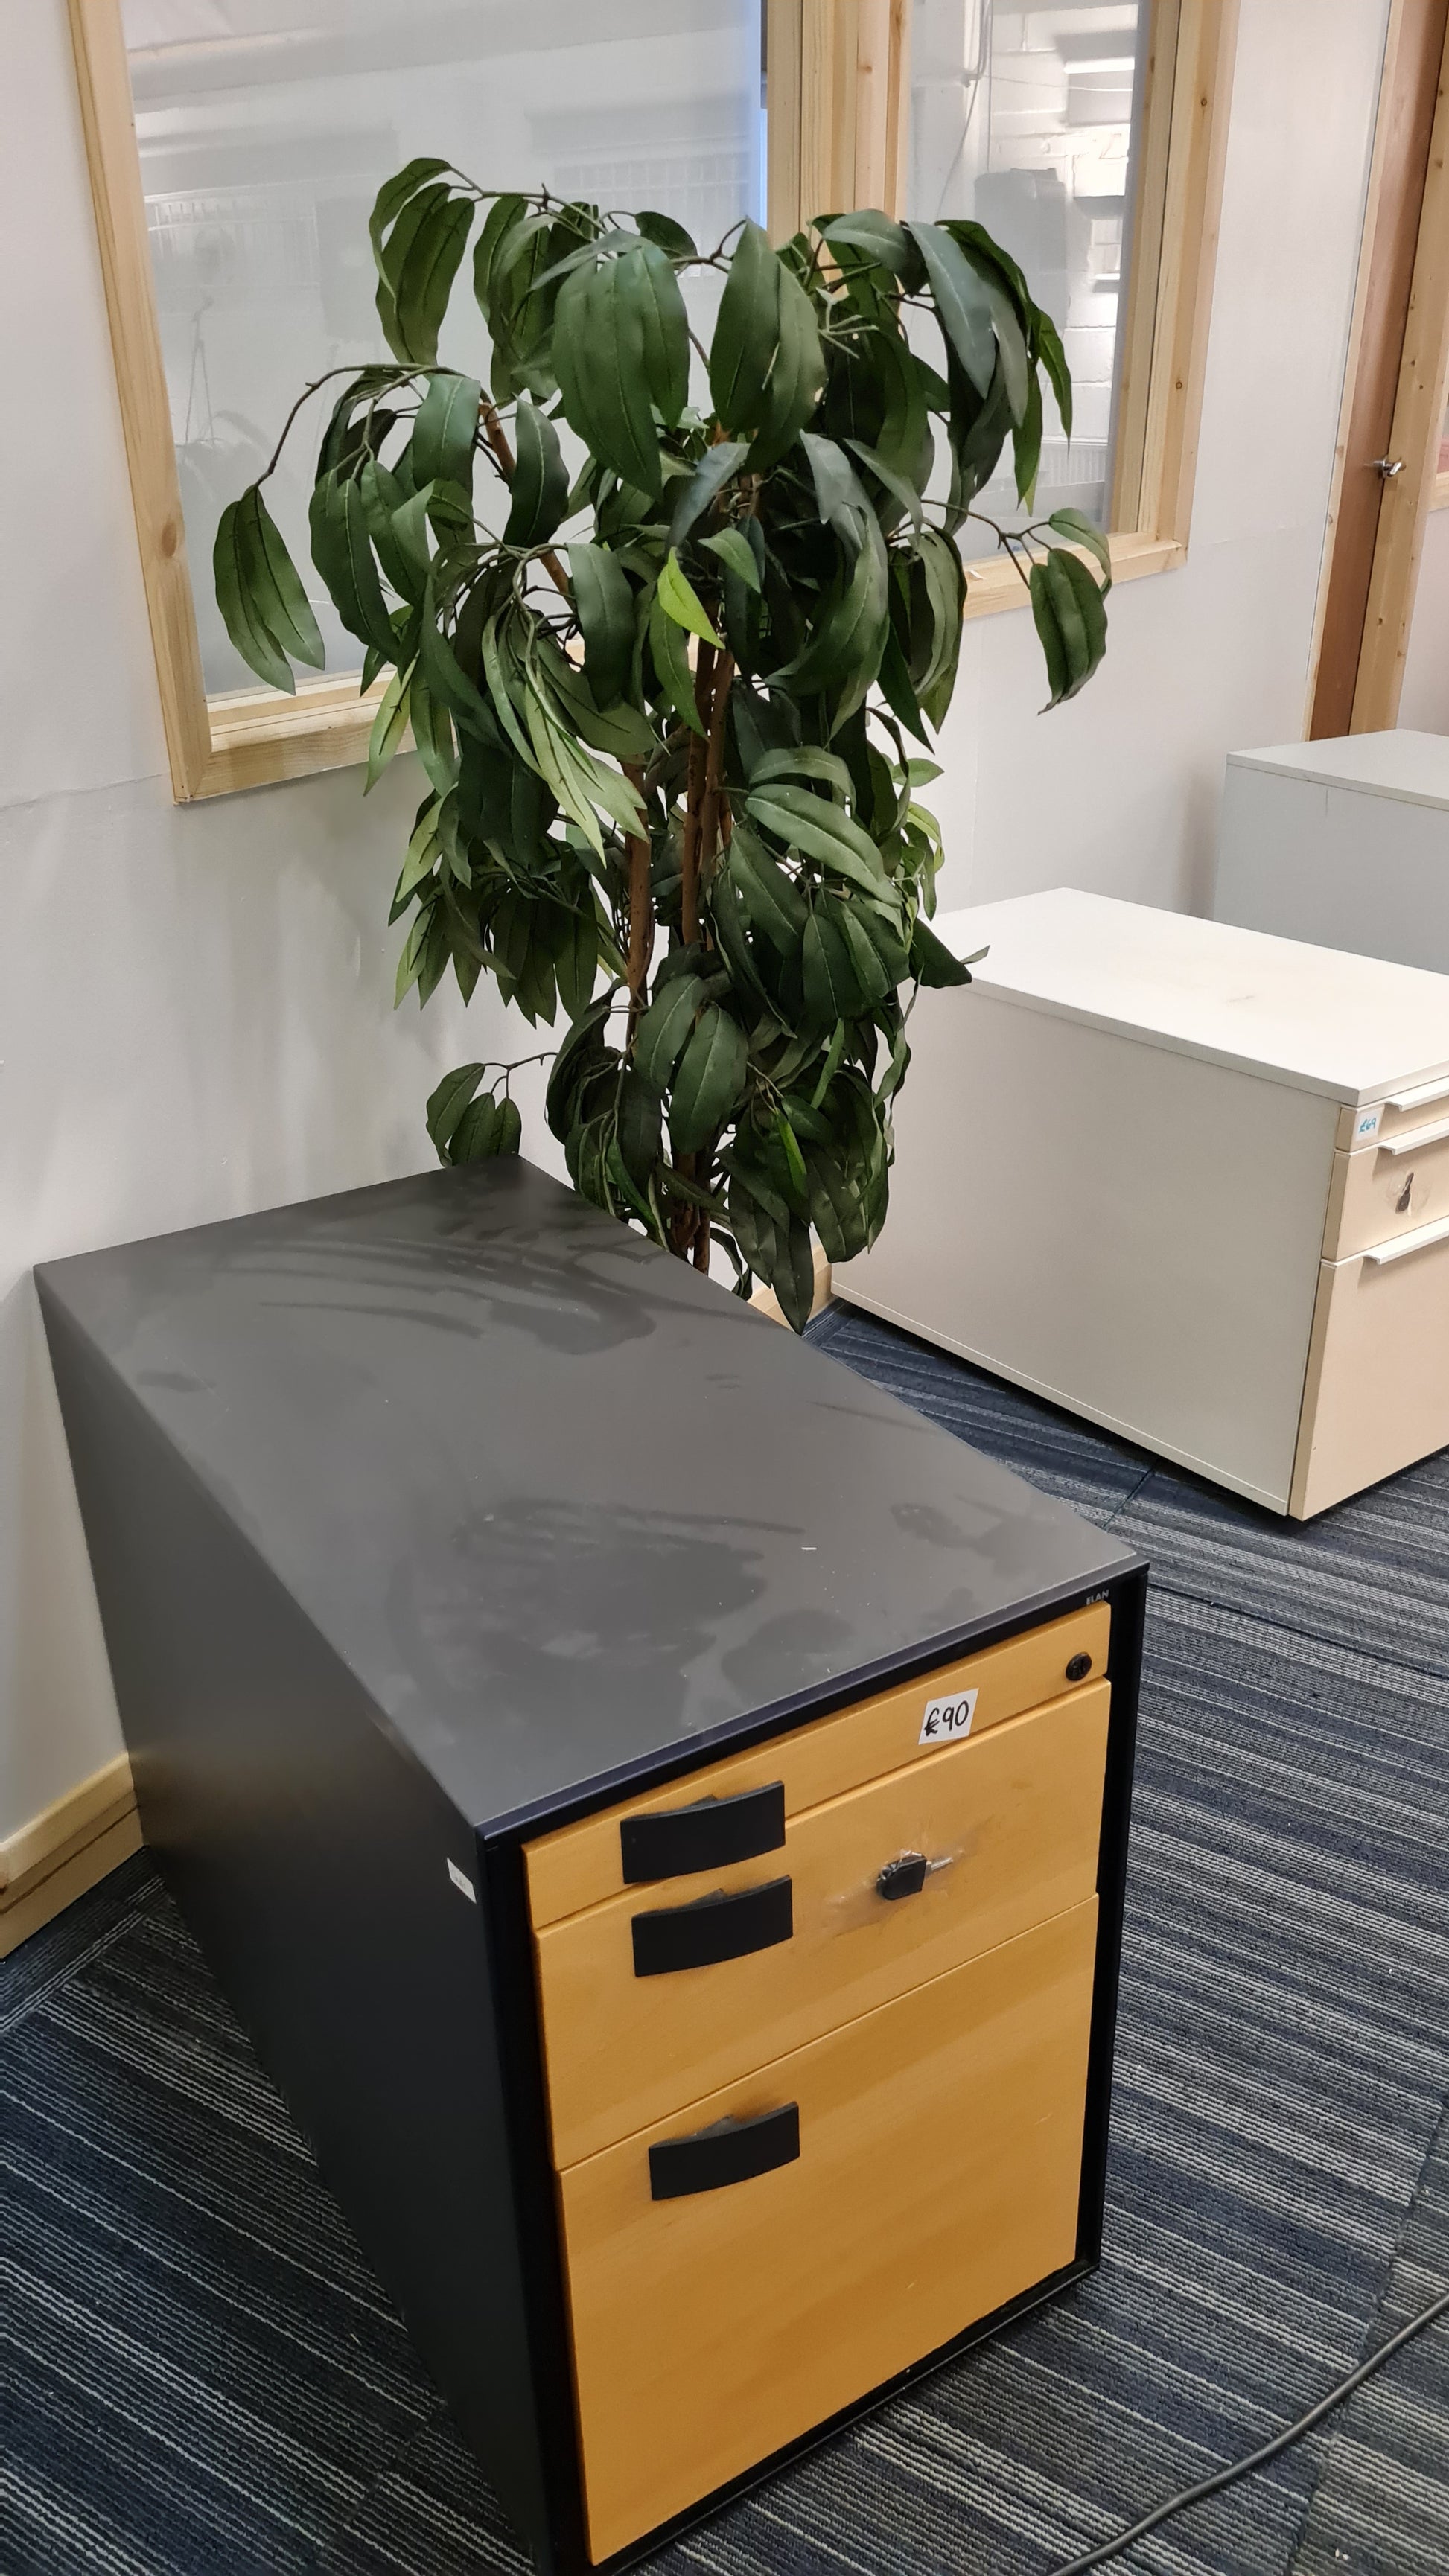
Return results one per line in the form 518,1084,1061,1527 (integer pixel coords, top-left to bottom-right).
214,176,1111,1329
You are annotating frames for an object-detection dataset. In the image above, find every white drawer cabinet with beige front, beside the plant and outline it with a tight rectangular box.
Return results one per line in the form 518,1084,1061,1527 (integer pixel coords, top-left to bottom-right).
832,889,1449,1517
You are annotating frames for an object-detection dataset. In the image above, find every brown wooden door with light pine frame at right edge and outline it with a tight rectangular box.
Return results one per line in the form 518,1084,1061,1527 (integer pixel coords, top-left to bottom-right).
1305,0,1449,742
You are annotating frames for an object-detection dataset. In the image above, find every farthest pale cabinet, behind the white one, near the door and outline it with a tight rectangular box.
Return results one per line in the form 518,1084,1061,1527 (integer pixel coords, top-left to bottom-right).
1211,732,1449,974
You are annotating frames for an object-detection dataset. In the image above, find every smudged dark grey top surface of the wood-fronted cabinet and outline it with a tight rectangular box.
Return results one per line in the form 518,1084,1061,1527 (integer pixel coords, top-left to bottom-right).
39,1161,1132,1826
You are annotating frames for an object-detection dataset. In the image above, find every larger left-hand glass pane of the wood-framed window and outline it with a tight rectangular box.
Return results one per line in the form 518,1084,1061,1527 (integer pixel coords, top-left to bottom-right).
124,0,765,690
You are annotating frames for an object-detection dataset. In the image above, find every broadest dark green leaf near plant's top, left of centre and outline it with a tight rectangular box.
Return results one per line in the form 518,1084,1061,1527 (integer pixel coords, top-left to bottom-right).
554,250,663,500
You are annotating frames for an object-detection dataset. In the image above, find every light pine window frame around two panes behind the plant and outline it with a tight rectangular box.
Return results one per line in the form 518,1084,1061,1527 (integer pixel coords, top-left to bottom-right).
67,0,1238,804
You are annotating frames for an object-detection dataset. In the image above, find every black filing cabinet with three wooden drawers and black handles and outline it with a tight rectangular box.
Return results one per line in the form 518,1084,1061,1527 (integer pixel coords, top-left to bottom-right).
39,1164,1144,2571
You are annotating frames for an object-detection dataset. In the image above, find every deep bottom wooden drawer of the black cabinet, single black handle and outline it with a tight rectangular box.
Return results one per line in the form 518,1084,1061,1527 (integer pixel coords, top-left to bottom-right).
557,1898,1096,2560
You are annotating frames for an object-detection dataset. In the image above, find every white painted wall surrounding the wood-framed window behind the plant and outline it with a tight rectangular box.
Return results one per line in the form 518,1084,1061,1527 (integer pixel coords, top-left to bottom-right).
0,0,1408,1837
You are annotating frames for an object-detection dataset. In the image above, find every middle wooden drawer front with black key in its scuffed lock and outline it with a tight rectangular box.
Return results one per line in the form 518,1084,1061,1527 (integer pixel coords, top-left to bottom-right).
536,1682,1111,2167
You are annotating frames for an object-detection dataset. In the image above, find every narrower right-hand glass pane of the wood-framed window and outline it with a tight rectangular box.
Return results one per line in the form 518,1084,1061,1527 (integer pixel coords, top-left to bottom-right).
908,0,1147,536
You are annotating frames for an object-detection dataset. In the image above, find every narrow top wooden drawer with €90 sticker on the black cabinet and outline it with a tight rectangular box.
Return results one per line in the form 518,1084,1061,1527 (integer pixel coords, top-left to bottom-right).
526,1602,1111,1930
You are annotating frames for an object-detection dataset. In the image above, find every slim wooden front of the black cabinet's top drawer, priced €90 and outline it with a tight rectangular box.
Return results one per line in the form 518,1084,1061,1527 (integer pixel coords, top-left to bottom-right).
526,1602,1111,1925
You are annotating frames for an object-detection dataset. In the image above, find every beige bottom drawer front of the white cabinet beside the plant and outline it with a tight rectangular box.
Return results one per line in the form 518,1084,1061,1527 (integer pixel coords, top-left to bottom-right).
1289,1219,1449,1520
